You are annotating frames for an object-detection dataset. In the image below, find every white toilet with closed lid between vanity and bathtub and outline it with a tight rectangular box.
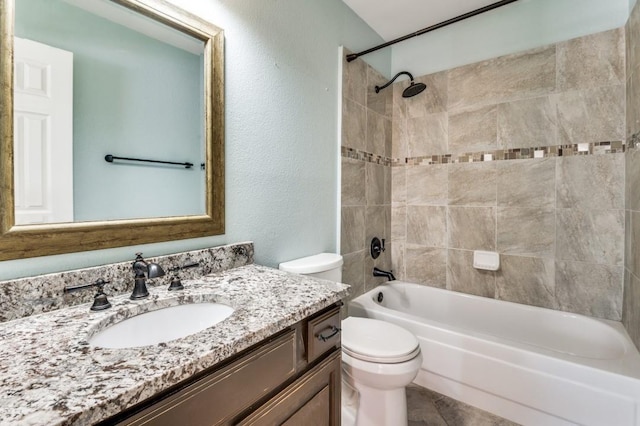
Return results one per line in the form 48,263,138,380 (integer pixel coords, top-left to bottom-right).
279,253,422,426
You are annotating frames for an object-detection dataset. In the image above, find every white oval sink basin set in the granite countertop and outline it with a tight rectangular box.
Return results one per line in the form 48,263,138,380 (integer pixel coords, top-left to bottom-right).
89,303,234,349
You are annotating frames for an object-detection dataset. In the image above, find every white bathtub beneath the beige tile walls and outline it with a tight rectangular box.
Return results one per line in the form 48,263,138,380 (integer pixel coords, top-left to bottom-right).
349,281,640,426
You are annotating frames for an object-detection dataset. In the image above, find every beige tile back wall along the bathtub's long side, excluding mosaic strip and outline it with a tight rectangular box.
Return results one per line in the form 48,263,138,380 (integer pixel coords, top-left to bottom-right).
390,29,624,322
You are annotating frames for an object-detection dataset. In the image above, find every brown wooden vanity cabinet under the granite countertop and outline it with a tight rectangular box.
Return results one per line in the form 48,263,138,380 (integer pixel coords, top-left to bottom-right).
109,306,341,426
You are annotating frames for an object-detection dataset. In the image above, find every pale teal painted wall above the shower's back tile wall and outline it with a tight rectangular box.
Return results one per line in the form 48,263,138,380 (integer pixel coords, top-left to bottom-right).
392,0,635,75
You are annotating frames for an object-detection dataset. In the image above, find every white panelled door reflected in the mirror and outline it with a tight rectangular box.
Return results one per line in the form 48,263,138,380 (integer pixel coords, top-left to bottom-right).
14,37,73,225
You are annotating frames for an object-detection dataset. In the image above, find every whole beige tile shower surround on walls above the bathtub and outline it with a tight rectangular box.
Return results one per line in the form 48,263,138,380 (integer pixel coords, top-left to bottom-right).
342,24,640,332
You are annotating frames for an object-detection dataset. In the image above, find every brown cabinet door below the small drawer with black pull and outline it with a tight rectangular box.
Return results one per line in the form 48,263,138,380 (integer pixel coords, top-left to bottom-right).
239,350,341,426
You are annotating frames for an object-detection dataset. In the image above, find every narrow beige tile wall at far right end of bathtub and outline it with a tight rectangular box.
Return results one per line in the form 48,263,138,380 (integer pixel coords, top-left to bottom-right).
622,0,640,348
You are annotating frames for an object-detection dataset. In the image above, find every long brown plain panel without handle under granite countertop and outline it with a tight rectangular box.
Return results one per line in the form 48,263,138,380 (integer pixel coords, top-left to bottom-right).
121,330,296,426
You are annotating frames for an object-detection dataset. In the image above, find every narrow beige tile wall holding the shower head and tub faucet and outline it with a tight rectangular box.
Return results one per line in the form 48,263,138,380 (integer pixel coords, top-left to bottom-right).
340,52,393,297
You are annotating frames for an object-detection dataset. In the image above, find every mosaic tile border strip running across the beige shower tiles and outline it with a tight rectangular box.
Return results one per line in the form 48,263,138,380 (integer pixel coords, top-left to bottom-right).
341,141,624,167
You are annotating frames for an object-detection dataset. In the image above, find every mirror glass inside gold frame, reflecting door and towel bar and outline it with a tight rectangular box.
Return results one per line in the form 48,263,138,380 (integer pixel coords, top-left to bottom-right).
14,0,206,225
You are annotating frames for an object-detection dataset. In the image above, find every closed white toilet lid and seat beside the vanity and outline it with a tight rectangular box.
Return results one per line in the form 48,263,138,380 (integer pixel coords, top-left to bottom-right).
342,317,420,364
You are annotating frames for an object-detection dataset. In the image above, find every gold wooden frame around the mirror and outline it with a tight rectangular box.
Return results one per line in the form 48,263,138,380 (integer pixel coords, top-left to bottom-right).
0,0,224,260
